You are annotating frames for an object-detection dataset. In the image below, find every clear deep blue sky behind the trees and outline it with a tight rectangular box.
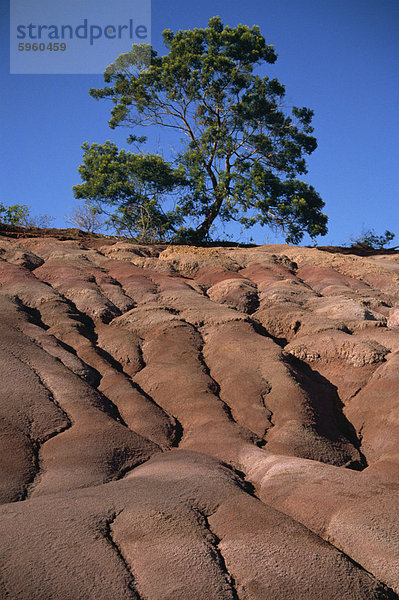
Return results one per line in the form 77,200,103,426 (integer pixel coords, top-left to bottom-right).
0,0,399,245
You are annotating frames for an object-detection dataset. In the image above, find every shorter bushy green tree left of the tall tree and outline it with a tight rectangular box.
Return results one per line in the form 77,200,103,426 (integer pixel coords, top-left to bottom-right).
73,141,184,241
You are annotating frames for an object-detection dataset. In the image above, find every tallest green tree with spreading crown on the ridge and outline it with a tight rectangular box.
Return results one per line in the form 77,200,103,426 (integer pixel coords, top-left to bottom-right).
90,17,327,242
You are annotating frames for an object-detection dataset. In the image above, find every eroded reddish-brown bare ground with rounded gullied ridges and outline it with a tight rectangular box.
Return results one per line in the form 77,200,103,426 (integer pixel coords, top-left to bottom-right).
0,236,399,600
